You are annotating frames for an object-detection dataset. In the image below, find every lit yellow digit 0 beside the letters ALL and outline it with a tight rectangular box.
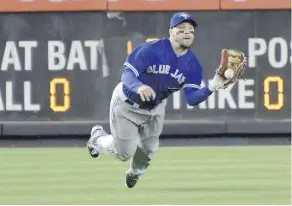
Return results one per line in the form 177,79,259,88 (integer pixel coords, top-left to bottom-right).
50,78,71,112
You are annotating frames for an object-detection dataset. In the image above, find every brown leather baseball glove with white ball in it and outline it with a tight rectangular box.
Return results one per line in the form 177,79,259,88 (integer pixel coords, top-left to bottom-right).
216,49,247,89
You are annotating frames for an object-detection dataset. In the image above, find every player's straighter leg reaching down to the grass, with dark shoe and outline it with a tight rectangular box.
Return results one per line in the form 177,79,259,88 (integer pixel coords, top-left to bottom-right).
126,105,165,188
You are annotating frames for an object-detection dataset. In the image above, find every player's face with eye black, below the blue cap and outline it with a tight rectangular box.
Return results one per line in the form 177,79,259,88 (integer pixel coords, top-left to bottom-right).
170,22,195,49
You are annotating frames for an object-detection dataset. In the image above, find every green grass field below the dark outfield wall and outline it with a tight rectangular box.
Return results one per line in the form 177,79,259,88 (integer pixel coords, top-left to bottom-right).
0,146,291,205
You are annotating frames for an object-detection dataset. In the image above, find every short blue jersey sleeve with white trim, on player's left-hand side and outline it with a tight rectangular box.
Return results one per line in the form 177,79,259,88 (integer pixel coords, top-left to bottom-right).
124,43,151,77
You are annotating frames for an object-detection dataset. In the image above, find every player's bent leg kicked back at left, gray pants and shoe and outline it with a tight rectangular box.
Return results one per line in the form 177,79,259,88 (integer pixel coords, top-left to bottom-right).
88,83,147,161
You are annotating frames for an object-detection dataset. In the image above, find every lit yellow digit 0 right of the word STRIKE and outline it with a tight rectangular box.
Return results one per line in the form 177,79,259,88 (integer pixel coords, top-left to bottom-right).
264,76,284,110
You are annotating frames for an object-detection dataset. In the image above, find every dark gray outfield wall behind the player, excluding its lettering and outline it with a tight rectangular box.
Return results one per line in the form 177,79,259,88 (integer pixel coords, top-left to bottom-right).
0,11,291,135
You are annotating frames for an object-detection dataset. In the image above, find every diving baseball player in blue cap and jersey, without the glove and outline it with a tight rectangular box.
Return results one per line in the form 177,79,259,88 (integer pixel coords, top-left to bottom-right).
87,12,246,188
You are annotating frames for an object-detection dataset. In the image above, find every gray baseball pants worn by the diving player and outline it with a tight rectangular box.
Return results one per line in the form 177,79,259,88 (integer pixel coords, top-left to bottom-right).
94,83,166,175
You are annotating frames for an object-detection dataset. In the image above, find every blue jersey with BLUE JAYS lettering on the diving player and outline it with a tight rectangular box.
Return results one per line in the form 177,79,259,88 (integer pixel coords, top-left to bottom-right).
123,38,203,107
